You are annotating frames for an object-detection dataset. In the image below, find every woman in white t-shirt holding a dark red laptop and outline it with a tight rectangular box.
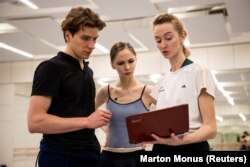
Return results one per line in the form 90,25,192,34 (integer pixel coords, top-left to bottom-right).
148,13,216,152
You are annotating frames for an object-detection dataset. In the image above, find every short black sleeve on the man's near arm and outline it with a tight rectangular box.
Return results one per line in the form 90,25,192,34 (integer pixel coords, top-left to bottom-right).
31,61,61,97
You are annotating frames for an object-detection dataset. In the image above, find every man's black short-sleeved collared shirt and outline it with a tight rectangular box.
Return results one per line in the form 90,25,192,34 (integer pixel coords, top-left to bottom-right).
31,52,100,151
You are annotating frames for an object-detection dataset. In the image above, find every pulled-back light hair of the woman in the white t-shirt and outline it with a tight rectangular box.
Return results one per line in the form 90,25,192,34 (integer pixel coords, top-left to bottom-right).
153,13,190,57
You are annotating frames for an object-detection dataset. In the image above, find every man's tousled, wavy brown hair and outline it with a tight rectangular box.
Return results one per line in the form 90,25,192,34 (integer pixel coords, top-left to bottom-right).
61,7,106,41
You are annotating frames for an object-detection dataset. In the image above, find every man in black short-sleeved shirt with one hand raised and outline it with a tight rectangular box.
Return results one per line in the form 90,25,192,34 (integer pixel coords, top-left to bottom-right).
28,7,111,167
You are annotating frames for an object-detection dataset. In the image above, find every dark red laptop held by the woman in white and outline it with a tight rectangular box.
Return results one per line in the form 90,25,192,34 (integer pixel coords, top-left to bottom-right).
126,104,189,144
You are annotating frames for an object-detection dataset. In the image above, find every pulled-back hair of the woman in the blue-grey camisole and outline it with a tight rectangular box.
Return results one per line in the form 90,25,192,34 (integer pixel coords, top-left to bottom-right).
110,42,136,62
